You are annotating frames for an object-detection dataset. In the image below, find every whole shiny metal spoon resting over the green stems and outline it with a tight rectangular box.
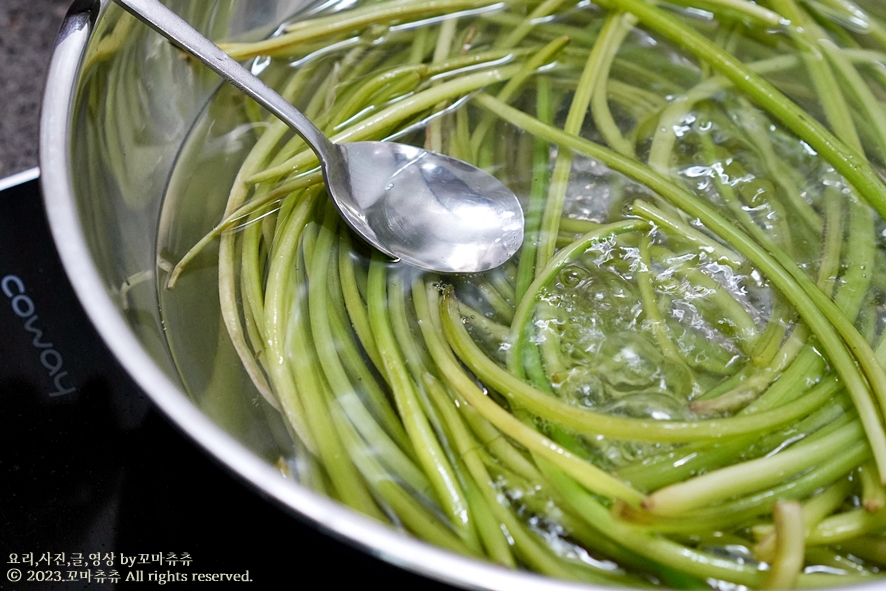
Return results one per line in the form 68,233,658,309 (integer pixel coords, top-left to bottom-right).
116,0,523,273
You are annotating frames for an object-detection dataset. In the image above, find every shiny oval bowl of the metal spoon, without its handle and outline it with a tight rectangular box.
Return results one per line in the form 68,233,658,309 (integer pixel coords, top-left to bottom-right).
325,142,523,273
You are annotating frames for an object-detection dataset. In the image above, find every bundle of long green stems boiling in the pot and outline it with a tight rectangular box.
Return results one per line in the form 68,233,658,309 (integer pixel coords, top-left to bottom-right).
169,0,886,589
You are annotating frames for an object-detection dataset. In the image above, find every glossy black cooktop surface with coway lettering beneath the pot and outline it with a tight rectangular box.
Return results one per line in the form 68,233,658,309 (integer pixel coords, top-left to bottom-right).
0,173,458,591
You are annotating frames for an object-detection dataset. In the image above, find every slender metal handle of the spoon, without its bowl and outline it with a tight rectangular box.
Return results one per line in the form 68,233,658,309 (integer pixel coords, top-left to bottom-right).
115,0,336,160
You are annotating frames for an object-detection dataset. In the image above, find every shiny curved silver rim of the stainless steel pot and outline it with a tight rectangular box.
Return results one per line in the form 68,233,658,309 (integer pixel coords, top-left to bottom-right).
39,0,883,591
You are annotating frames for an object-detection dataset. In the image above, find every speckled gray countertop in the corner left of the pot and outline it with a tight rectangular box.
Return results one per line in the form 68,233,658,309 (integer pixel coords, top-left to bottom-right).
0,0,71,178
